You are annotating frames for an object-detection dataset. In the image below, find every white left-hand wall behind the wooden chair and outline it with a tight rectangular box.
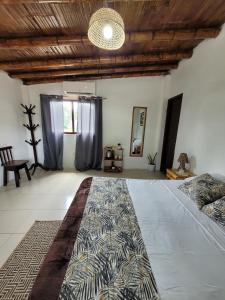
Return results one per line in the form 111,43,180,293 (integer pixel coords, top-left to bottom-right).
0,72,28,186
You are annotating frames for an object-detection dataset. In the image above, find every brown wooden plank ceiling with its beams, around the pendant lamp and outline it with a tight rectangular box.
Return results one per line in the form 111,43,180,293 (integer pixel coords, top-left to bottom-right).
0,0,225,84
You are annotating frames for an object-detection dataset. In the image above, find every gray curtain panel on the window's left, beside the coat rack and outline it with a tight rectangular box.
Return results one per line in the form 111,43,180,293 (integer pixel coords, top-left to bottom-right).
40,95,64,170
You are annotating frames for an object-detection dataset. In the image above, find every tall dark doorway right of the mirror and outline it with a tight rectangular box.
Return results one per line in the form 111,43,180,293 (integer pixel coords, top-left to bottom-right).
160,94,183,172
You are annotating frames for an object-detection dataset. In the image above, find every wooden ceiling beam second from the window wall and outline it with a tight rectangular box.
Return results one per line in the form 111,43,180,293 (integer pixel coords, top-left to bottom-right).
9,63,178,79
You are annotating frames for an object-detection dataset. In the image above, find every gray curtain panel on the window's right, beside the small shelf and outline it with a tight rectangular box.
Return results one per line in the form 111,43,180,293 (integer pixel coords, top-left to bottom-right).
75,97,102,171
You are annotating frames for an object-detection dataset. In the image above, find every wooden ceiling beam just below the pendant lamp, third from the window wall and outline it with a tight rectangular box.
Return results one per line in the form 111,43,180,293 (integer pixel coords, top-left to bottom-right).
0,50,192,71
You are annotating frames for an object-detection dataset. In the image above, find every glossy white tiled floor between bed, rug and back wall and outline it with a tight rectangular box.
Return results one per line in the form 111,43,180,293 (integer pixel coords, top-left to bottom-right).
0,170,165,266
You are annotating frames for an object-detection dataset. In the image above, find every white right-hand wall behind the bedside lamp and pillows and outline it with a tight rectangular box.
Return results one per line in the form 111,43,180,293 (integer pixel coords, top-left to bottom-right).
166,28,225,174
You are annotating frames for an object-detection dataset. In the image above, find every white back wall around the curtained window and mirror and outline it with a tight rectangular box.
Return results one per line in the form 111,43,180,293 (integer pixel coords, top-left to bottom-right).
23,77,164,169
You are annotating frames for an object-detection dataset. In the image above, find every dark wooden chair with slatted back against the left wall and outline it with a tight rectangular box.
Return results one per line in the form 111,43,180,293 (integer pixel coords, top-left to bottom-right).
0,146,31,187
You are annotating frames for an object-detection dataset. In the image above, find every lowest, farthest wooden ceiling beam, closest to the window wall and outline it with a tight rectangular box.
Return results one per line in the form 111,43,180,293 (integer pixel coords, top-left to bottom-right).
23,71,169,85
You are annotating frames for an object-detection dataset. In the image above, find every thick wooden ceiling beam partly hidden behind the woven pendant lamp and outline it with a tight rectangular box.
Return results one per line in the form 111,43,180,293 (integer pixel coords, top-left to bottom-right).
0,27,220,49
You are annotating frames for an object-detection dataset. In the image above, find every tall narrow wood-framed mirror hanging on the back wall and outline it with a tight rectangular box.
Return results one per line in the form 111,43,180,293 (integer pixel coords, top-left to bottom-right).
130,106,147,157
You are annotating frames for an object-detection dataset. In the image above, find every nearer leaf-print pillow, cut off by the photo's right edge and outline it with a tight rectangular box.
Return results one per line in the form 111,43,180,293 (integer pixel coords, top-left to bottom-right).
202,197,225,228
